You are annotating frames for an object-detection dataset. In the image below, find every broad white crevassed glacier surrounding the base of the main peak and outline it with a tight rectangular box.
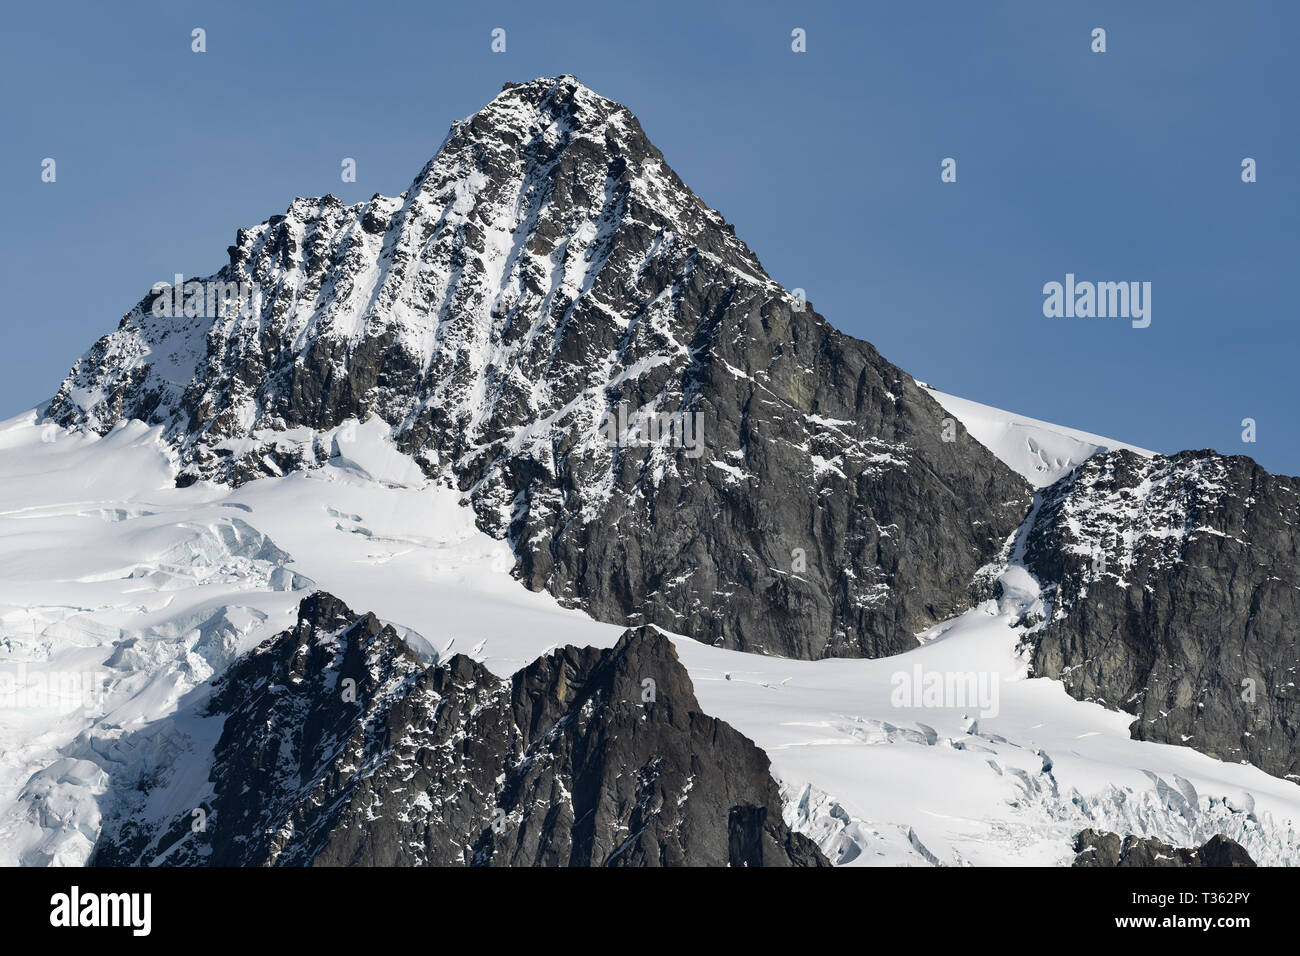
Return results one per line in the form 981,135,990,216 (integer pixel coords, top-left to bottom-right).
0,408,1300,865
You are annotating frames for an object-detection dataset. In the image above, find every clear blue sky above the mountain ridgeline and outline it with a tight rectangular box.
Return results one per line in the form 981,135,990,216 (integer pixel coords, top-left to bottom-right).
0,0,1300,475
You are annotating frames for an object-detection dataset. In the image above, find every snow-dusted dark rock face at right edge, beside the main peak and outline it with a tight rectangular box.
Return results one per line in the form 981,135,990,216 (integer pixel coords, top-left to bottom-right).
1026,451,1300,779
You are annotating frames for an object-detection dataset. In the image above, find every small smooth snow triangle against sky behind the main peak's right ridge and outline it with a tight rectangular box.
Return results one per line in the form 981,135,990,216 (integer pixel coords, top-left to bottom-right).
917,382,1154,488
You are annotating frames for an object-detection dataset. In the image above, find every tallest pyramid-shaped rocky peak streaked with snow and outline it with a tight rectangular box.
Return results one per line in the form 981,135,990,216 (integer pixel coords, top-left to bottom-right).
49,77,1031,658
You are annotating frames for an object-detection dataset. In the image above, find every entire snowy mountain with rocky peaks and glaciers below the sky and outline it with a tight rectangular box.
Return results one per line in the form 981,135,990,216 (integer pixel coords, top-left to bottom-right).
0,77,1300,865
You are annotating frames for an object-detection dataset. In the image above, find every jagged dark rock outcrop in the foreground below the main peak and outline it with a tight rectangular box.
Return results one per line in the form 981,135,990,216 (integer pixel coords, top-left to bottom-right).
92,593,828,866
